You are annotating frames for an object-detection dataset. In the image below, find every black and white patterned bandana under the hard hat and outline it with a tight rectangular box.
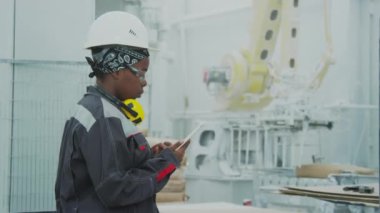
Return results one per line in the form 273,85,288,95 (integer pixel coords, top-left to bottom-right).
86,46,149,78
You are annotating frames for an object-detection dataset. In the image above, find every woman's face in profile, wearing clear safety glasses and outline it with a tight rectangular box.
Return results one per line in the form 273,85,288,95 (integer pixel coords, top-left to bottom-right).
115,57,149,101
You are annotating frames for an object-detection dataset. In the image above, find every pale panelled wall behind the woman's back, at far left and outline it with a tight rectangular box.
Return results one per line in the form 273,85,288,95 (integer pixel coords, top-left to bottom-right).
0,0,95,212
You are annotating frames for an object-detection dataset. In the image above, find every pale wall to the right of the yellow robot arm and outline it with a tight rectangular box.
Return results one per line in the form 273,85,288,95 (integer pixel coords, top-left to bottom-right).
308,0,379,168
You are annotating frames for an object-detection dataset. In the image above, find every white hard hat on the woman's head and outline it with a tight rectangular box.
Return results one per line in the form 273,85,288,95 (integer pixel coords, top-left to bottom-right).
84,11,149,49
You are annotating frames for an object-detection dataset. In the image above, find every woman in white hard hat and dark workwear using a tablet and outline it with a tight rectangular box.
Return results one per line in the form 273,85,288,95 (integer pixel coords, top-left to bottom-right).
55,12,187,213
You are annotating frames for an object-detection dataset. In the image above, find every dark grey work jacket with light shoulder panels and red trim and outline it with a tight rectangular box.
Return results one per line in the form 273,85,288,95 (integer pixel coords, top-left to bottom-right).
55,87,179,213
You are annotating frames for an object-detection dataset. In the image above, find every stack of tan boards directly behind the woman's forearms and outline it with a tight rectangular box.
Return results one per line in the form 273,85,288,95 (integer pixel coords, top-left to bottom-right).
146,137,187,203
